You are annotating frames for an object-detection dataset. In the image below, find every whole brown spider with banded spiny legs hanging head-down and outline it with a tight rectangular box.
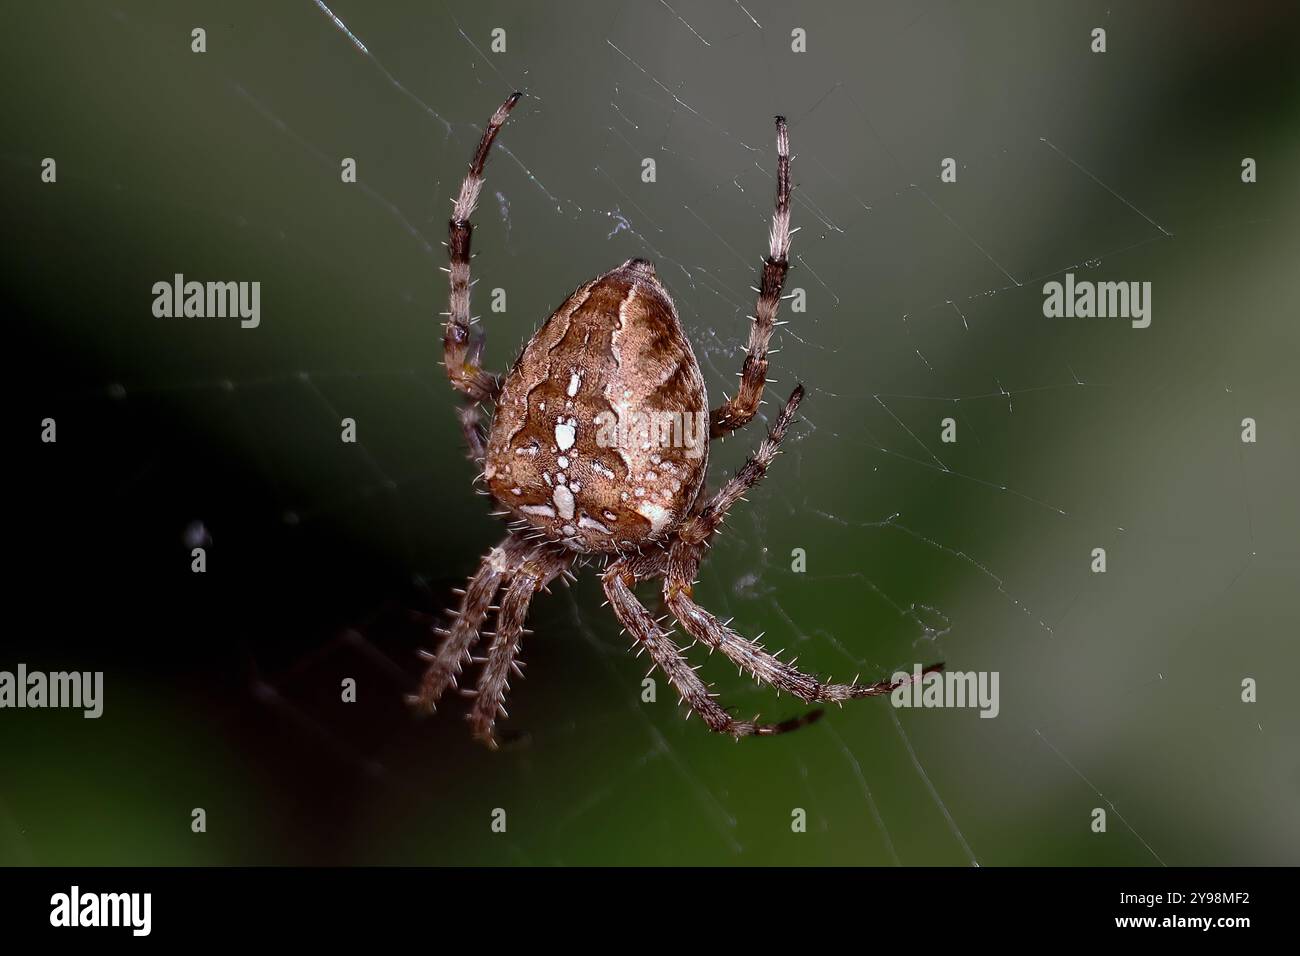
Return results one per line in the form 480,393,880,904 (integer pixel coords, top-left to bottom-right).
411,92,940,748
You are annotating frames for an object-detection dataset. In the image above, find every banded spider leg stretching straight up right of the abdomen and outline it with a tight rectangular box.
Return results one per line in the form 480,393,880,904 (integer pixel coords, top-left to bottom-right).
709,116,790,438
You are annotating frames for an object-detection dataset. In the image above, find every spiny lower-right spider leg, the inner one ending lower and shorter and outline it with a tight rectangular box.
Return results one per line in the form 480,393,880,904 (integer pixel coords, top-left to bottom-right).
602,561,820,737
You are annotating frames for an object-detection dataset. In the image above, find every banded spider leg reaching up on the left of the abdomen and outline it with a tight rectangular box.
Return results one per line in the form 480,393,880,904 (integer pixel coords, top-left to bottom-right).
442,92,521,460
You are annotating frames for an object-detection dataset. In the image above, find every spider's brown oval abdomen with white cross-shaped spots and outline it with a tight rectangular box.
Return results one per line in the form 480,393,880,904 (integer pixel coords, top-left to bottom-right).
484,259,709,553
